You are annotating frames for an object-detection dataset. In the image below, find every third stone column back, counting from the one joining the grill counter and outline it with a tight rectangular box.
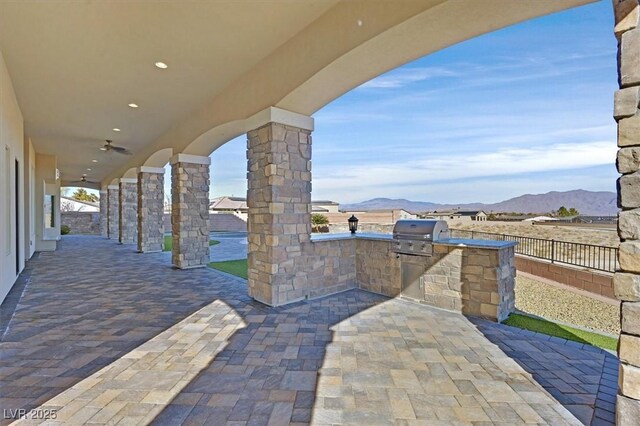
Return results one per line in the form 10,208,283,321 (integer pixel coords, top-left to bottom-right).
138,167,164,253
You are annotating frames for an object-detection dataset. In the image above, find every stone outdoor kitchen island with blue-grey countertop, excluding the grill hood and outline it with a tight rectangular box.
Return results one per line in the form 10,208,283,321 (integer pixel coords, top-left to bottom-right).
311,233,516,321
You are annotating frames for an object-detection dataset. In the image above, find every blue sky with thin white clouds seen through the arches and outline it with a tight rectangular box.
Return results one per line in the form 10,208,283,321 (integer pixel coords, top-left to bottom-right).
172,1,617,203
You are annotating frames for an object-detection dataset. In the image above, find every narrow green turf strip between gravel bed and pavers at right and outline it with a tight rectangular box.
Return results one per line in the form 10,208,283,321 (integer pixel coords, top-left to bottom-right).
503,314,618,351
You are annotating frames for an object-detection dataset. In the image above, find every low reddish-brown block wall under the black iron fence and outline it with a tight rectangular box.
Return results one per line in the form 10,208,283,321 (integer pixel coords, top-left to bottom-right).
516,256,615,299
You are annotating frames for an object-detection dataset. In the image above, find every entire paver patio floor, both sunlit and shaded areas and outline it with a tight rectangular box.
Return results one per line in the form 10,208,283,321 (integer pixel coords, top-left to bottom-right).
0,236,617,425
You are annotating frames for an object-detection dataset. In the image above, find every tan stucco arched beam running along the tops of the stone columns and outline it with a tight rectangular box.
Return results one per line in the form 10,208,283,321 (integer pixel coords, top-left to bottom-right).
105,0,592,181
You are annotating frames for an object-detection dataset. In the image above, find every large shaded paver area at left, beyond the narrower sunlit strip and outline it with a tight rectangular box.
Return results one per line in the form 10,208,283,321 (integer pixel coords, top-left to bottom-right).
0,235,255,423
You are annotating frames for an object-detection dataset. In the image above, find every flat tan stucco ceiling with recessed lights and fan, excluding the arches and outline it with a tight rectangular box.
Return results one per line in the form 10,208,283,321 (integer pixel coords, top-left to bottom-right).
0,0,336,185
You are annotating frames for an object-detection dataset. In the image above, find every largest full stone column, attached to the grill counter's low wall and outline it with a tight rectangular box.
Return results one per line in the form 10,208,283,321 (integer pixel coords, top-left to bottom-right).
247,110,313,306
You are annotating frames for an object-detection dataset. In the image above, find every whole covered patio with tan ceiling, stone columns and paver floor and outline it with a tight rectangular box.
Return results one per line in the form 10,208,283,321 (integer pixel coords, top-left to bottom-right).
0,0,640,425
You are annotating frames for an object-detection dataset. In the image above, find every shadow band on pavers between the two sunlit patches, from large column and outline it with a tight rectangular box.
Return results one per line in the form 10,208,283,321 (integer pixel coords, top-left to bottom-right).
154,290,389,425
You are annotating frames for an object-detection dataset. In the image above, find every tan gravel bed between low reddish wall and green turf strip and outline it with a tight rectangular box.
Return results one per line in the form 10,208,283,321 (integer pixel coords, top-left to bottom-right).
516,275,620,334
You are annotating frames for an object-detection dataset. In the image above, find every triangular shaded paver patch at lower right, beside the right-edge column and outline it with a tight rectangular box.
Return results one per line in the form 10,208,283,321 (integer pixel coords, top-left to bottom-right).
470,318,619,425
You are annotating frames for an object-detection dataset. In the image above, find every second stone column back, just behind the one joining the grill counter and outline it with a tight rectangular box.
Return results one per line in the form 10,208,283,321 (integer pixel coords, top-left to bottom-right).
170,154,211,269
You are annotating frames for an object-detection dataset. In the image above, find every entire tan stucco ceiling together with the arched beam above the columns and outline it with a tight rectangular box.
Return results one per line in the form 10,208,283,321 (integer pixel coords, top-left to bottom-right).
0,0,592,185
